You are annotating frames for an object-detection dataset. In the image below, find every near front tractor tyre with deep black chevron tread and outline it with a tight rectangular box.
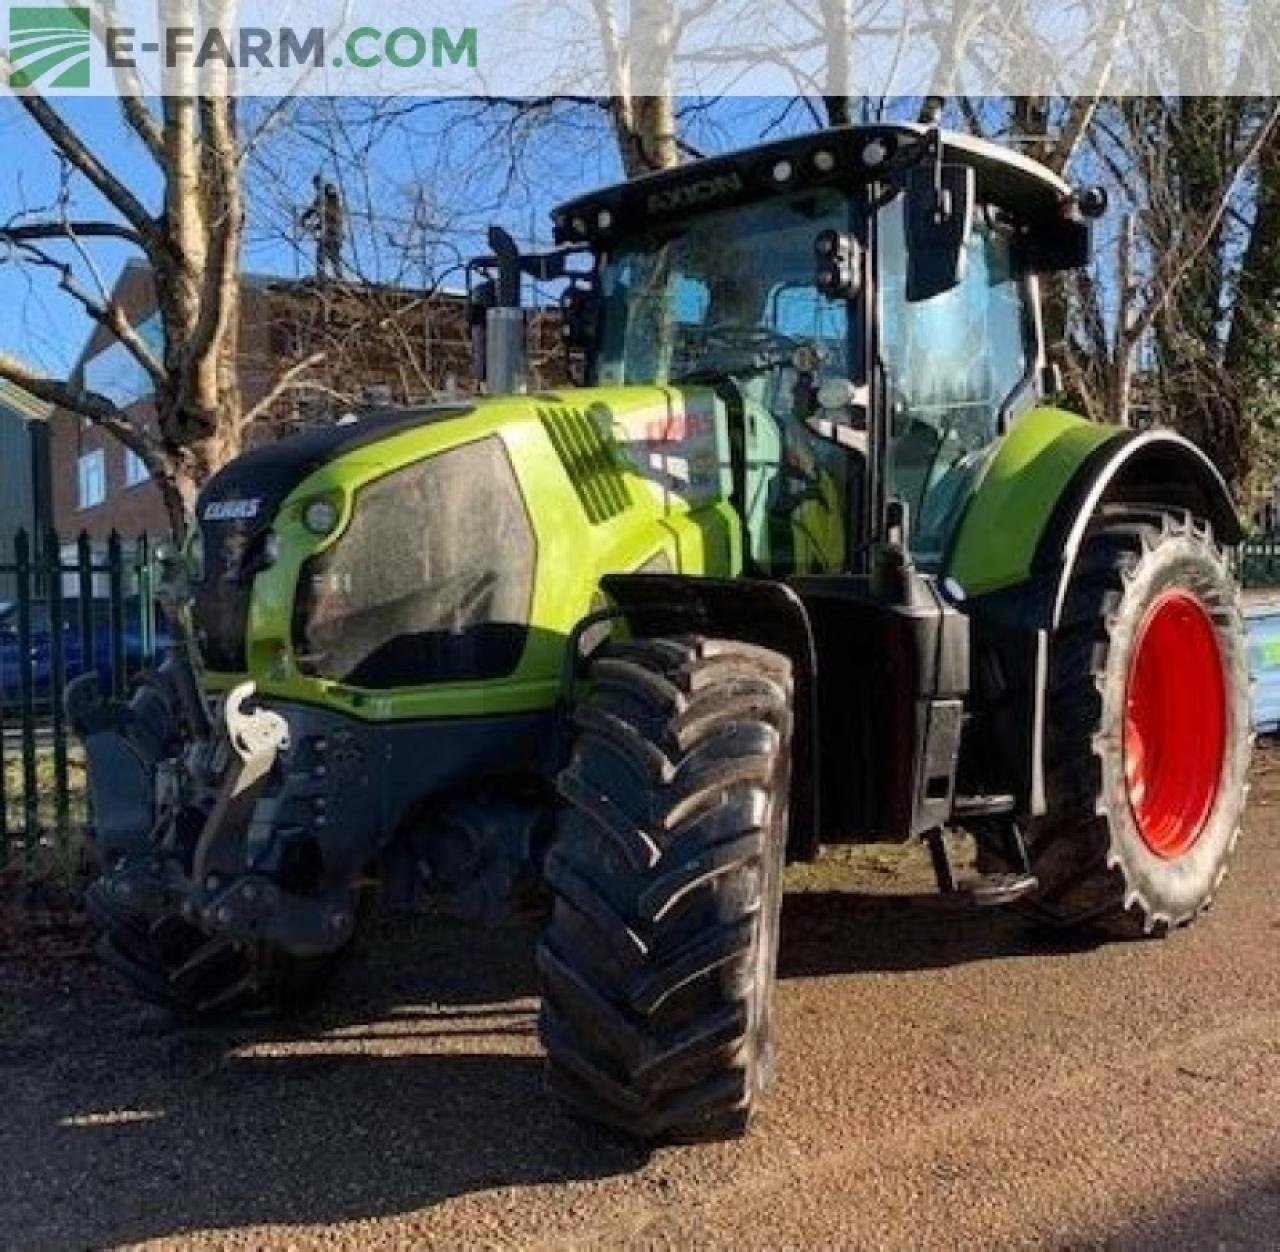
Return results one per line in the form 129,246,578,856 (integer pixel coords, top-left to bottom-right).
538,638,791,1141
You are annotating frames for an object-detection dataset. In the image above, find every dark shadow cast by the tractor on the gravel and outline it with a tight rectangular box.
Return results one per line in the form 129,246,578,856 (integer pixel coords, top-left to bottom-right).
10,860,1090,1247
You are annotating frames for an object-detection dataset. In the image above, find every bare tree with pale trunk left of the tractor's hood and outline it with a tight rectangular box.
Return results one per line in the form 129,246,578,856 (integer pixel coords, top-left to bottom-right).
0,0,262,531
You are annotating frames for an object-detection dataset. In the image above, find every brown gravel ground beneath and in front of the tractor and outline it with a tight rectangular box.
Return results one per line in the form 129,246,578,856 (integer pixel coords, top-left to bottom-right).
0,753,1280,1249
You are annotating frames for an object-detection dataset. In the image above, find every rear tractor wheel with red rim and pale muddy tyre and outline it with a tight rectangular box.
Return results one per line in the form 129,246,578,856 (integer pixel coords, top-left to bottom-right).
1003,510,1252,937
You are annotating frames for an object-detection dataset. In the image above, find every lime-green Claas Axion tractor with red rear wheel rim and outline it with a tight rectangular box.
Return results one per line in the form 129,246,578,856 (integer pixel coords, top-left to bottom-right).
68,125,1249,1139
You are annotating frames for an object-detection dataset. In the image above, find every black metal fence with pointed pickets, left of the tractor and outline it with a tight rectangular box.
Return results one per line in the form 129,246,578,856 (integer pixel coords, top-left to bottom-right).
0,531,157,876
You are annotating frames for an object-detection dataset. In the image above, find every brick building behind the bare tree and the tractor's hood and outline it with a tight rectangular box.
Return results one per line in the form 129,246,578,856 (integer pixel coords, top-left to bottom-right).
49,262,557,543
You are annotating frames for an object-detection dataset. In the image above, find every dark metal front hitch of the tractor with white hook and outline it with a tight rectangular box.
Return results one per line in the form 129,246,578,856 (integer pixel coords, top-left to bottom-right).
76,658,356,956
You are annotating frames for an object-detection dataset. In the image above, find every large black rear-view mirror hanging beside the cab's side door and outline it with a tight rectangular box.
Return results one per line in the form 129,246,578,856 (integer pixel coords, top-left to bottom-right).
906,163,975,303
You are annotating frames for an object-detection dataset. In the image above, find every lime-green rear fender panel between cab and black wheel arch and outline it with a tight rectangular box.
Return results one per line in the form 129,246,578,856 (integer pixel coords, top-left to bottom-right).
943,408,1125,597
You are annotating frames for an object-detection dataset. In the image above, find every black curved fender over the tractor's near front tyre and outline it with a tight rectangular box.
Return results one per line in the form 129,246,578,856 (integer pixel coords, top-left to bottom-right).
600,574,819,860
